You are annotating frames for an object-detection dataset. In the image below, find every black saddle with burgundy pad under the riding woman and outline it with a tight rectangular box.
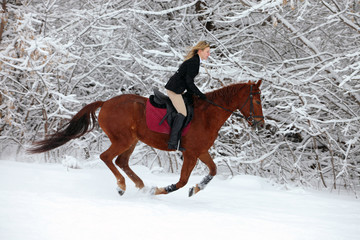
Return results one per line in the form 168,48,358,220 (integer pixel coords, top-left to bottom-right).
146,88,194,135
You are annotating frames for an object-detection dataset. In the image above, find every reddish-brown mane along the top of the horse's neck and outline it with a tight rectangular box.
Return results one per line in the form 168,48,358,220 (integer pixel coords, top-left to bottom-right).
207,82,254,105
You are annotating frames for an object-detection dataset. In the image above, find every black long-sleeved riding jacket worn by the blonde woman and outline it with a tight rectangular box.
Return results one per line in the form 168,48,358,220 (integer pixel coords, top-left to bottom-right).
165,54,205,98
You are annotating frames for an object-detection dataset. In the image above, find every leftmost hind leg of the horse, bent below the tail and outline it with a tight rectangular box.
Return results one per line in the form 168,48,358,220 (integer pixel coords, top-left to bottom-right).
100,144,126,195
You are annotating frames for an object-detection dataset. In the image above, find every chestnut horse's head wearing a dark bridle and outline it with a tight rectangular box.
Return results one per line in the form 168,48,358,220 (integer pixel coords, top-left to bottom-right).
239,80,265,130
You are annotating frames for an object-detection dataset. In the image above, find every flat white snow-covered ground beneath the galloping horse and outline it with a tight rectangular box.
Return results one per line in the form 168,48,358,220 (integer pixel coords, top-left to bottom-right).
0,160,360,240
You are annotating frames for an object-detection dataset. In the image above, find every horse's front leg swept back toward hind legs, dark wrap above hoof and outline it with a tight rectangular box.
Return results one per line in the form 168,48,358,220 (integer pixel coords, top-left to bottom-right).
153,151,197,195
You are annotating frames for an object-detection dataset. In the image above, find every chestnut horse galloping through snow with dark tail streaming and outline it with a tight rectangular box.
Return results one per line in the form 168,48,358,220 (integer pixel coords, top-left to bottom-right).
29,80,264,196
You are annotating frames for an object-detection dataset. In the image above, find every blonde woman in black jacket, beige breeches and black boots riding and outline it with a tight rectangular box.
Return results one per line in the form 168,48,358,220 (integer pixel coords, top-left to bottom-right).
165,41,210,151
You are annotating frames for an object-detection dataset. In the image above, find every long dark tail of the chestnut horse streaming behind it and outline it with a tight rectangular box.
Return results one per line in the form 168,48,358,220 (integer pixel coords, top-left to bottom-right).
28,101,104,153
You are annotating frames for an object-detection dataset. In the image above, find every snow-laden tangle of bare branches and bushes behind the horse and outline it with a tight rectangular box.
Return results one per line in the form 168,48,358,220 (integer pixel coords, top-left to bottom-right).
0,0,360,194
